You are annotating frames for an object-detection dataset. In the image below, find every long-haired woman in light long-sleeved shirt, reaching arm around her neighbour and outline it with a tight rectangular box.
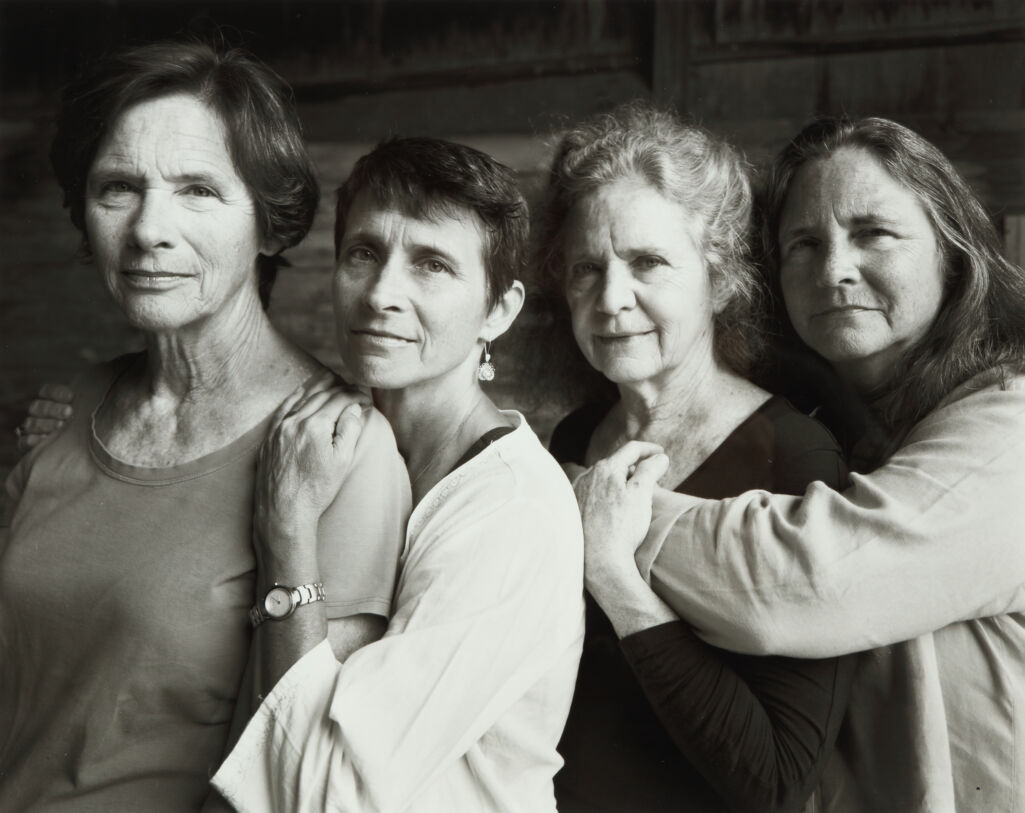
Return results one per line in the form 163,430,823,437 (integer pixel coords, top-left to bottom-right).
592,119,1025,813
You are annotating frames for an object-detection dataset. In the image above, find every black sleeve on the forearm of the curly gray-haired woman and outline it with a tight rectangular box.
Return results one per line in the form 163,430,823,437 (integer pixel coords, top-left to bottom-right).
620,621,856,811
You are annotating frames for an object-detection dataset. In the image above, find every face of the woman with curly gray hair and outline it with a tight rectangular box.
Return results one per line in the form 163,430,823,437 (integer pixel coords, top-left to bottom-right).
564,178,714,384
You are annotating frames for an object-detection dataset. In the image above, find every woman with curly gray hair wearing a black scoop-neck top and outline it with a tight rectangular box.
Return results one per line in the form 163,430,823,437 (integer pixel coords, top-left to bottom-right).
538,104,851,811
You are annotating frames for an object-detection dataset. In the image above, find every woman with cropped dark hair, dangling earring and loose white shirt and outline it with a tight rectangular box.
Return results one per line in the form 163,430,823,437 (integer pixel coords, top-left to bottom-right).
213,138,583,813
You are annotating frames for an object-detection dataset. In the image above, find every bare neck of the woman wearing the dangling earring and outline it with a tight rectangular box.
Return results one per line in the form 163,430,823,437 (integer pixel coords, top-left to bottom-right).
373,365,507,504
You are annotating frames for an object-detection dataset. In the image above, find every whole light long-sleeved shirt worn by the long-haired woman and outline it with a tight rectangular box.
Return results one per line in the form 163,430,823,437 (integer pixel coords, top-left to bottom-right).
637,374,1025,813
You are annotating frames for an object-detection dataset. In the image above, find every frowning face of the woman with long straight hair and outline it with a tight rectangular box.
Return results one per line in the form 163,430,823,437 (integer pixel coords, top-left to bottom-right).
779,148,944,391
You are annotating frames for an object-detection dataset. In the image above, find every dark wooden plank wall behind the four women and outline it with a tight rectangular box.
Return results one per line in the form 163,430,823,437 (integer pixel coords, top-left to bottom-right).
0,0,1025,492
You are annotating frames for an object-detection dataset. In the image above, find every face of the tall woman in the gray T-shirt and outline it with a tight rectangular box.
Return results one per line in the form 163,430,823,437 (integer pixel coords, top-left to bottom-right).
85,94,272,331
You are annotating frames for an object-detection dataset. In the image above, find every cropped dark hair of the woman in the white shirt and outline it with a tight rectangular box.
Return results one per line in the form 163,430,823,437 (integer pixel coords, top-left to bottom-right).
334,138,530,308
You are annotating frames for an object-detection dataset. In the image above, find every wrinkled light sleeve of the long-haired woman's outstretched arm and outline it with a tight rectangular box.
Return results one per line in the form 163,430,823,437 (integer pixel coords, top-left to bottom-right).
638,377,1025,657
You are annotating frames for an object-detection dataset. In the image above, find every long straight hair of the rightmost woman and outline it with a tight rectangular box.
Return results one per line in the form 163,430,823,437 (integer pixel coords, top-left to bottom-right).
763,118,1025,440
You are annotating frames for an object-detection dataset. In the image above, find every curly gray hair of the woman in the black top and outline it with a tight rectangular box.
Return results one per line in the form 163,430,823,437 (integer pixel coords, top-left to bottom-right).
535,101,763,374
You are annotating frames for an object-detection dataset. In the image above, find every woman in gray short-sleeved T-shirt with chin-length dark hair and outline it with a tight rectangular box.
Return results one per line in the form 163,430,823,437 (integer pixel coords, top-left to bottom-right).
0,43,409,811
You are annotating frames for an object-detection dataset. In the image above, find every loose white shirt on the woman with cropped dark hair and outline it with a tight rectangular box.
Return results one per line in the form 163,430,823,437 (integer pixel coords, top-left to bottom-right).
213,413,583,813
